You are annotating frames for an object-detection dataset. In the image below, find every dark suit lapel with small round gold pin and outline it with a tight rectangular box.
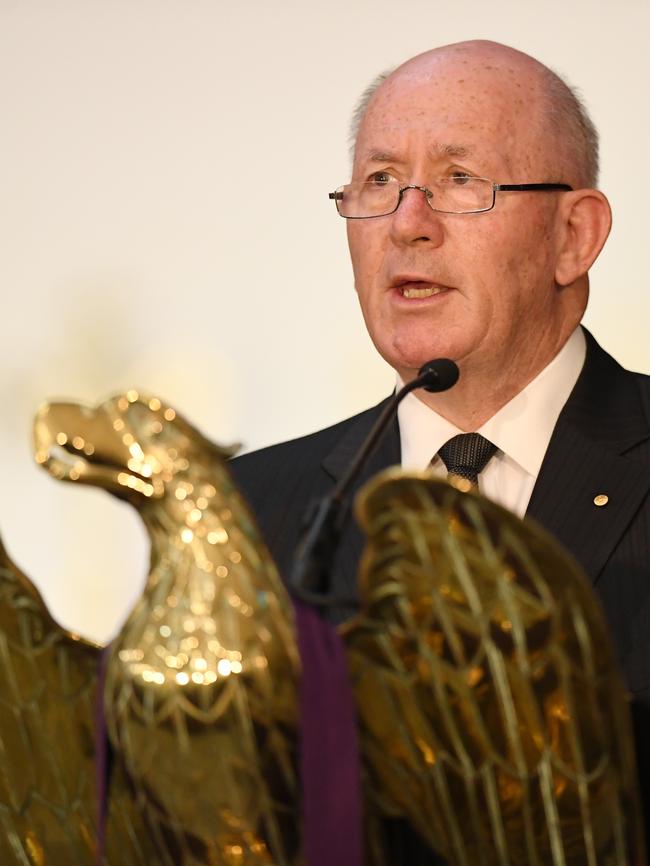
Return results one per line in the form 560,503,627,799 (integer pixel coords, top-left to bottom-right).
526,333,650,582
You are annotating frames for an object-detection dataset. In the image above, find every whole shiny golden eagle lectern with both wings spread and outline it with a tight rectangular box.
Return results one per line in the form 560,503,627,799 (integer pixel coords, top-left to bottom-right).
0,391,644,866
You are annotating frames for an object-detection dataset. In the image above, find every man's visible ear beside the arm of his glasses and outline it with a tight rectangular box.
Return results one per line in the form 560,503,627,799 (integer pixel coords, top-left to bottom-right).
555,189,612,286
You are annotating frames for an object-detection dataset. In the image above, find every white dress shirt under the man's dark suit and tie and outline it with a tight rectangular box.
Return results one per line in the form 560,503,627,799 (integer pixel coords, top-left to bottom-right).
397,328,587,517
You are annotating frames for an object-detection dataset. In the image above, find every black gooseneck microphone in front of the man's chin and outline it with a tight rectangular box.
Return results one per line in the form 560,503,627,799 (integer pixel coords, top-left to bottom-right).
289,358,459,606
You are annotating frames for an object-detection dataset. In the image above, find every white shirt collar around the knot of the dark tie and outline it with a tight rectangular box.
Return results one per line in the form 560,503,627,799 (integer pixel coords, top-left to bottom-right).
397,327,587,477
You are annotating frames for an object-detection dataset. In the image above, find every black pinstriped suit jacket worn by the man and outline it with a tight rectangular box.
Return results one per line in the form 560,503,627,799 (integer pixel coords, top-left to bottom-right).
231,333,650,866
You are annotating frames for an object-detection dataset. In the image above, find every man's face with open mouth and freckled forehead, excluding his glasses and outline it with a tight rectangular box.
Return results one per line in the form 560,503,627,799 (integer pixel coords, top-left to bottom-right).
347,54,576,379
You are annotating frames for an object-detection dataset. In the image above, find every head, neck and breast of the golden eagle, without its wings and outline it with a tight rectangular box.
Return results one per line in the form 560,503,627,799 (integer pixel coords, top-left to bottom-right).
34,391,300,866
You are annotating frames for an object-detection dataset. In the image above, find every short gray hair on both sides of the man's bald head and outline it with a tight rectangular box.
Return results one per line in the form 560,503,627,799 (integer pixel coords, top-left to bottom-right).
348,66,599,187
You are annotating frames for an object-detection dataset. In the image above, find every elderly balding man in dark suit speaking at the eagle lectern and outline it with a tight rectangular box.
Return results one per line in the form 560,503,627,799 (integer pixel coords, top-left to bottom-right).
233,42,650,864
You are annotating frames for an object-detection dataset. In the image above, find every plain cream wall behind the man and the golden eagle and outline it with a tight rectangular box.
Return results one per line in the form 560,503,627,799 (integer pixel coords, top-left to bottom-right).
0,0,650,640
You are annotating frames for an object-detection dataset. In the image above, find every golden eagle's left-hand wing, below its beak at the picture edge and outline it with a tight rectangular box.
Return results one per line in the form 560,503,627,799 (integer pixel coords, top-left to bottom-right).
0,542,156,866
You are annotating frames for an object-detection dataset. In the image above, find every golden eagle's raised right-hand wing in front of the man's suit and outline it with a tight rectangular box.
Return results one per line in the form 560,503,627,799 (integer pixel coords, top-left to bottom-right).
344,472,644,866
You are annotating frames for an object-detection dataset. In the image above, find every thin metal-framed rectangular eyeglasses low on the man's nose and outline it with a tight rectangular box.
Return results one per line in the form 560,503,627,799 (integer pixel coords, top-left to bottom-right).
329,175,573,220
